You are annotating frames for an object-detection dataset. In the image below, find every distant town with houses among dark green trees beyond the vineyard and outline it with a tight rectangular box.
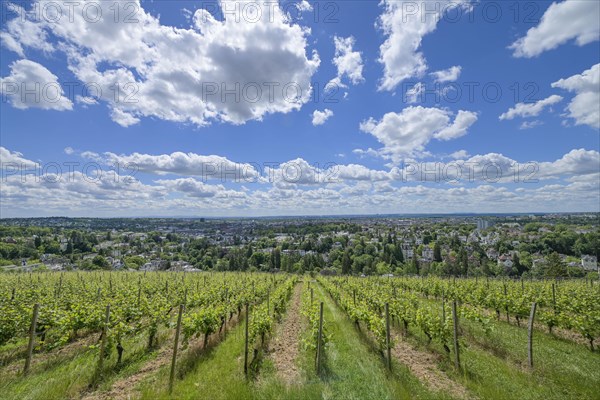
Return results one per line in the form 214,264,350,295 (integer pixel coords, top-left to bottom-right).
0,213,600,278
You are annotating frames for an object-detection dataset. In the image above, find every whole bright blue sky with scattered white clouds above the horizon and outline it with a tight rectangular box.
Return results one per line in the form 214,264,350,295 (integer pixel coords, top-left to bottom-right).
0,0,600,217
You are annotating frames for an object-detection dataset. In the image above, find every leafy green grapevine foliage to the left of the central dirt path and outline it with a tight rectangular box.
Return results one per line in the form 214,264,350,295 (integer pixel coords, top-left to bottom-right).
0,272,292,374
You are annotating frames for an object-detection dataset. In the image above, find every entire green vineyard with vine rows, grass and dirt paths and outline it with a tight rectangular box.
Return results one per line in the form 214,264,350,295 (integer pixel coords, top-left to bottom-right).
0,272,600,399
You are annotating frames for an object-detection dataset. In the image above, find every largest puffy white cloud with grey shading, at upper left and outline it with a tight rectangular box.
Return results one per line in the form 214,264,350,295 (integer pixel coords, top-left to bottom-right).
2,0,320,126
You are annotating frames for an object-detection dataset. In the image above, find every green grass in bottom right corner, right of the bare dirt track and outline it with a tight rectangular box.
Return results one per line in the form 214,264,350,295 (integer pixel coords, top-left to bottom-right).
392,296,600,400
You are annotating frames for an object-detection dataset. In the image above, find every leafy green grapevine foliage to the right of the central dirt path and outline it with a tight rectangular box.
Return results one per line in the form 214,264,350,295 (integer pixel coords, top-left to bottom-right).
321,278,600,352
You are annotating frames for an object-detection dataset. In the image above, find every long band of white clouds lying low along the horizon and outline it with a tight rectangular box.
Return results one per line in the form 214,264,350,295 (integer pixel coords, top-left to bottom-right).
0,147,600,217
